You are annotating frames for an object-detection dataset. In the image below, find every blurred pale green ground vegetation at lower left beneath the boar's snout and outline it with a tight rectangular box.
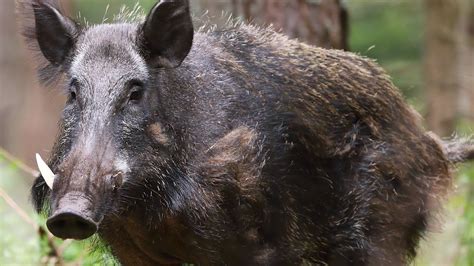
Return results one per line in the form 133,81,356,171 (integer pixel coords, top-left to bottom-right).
0,154,118,265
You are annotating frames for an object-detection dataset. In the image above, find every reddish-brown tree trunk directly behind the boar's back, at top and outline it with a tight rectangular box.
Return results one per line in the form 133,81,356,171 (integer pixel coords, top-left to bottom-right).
194,0,348,50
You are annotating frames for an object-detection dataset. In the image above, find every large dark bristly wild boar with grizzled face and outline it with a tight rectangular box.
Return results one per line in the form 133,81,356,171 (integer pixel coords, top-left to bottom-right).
18,0,474,265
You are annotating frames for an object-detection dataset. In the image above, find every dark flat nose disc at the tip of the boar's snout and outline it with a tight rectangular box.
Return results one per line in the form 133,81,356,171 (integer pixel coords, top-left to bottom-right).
46,212,98,239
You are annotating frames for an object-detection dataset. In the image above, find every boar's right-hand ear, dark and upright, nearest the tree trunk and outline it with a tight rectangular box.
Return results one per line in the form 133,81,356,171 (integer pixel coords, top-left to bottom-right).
139,0,194,68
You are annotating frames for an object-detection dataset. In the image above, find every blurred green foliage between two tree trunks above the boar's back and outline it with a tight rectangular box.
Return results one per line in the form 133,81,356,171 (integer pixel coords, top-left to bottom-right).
348,0,423,102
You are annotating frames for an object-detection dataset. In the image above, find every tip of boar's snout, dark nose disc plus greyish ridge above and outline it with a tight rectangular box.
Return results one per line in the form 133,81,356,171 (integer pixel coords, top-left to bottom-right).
46,193,99,240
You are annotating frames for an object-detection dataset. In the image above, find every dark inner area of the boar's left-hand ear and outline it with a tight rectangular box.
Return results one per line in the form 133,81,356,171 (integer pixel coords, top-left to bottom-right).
32,0,78,66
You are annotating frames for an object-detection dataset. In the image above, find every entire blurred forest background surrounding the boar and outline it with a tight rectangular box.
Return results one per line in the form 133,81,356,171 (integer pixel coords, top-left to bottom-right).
0,0,474,266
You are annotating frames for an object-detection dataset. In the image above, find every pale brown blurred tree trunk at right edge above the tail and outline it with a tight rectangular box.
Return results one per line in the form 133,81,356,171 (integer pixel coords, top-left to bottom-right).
424,0,474,136
